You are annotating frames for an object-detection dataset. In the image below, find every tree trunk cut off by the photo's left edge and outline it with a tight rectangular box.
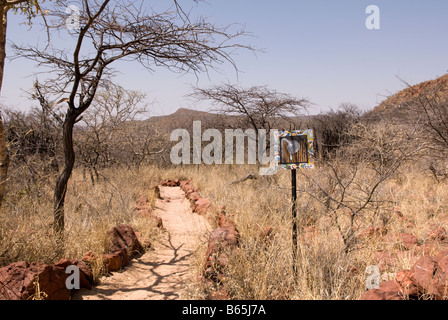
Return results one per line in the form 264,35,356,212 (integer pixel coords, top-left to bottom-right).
0,1,9,206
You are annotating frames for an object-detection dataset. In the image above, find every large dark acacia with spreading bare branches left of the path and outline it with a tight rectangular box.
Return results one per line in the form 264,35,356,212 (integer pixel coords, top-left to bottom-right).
14,0,250,234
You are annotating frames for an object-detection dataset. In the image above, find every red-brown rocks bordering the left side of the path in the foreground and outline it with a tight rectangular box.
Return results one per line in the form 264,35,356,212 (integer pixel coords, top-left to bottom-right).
0,192,162,300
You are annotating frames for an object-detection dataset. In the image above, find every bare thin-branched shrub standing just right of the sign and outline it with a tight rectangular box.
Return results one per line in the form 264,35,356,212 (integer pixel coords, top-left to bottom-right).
299,122,422,252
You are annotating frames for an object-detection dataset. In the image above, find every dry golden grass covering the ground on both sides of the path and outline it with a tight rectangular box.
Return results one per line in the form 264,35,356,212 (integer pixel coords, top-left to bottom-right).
0,159,448,300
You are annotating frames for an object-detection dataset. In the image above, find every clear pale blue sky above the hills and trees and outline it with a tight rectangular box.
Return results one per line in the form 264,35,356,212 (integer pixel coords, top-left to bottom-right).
1,0,448,115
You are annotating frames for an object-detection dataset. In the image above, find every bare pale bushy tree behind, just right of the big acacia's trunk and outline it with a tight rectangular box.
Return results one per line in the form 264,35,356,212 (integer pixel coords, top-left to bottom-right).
75,83,163,183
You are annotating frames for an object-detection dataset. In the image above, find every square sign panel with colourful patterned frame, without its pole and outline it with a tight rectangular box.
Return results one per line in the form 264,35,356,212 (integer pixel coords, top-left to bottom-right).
275,130,314,170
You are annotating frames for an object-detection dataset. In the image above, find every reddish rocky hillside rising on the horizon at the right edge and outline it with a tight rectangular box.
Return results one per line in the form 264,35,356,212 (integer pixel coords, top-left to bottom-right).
368,74,448,120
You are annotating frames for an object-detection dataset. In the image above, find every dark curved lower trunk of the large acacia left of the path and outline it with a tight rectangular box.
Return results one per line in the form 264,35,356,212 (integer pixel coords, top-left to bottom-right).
53,110,77,236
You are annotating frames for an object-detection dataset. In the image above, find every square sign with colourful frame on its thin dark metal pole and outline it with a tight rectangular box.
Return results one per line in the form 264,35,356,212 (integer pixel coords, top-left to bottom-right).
274,130,315,273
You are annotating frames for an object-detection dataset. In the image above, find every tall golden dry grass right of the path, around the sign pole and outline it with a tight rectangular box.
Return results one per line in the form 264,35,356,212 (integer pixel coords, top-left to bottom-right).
173,165,448,300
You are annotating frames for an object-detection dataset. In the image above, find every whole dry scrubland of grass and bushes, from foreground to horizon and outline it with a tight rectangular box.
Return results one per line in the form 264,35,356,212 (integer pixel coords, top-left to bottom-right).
0,76,448,299
